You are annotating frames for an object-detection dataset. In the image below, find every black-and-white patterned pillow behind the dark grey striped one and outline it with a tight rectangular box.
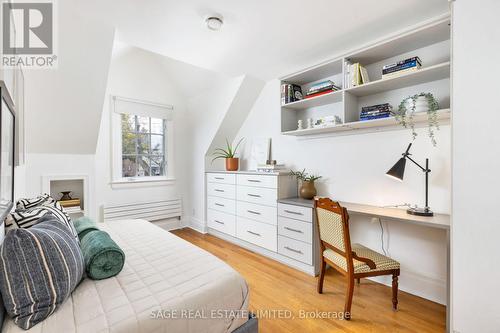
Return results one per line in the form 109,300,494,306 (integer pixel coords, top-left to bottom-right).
5,201,79,241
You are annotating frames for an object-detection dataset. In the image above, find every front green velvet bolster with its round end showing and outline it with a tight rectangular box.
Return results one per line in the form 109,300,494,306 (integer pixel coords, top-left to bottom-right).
80,230,125,280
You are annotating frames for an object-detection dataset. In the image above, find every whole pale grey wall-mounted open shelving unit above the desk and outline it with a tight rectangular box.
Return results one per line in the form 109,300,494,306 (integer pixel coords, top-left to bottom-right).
281,18,451,136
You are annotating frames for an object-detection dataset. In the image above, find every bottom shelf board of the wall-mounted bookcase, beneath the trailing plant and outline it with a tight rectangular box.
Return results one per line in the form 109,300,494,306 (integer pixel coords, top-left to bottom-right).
281,109,450,136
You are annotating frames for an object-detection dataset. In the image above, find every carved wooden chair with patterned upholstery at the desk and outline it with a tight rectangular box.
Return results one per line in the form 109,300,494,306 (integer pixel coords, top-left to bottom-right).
314,198,400,320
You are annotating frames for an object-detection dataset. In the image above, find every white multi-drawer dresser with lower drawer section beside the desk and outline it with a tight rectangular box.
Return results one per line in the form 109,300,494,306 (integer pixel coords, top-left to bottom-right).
206,171,317,275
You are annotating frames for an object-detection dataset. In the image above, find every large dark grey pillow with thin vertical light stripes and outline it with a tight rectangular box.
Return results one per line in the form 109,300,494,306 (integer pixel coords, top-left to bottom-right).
0,214,85,329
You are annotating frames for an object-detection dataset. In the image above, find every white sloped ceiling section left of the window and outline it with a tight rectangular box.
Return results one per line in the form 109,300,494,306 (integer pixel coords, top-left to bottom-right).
25,0,114,154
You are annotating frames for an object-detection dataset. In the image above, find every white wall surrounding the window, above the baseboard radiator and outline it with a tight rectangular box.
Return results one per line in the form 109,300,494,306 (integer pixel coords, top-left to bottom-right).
95,48,189,224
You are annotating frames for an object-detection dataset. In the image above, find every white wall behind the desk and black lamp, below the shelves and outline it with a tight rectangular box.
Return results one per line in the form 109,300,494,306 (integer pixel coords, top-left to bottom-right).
233,80,451,303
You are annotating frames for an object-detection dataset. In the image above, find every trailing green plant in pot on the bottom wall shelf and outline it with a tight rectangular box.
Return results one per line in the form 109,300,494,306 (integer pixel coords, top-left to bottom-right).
394,93,439,146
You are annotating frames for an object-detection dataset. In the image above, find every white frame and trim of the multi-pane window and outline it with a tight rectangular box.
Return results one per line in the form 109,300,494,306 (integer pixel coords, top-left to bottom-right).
110,96,175,186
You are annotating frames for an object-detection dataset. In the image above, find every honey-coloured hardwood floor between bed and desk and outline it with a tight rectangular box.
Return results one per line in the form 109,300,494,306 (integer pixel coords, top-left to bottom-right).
173,228,446,333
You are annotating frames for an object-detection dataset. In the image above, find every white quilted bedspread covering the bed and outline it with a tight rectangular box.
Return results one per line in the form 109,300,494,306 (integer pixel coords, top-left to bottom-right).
2,220,248,333
